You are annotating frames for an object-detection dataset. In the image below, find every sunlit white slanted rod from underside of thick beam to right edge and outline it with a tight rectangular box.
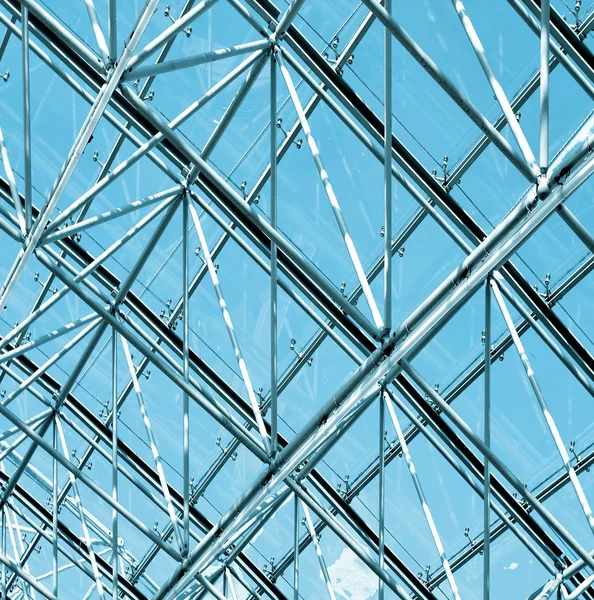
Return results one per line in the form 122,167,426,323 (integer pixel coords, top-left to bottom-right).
490,279,594,533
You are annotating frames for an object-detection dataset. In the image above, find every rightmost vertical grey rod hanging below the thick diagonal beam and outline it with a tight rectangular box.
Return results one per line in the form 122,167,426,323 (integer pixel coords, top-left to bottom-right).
483,277,491,600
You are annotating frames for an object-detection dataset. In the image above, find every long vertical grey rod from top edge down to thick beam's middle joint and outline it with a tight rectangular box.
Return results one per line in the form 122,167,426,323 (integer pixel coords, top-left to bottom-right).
379,0,392,332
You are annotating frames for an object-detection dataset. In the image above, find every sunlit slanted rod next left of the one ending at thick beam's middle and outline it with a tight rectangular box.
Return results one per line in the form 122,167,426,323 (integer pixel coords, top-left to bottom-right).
190,203,270,455
